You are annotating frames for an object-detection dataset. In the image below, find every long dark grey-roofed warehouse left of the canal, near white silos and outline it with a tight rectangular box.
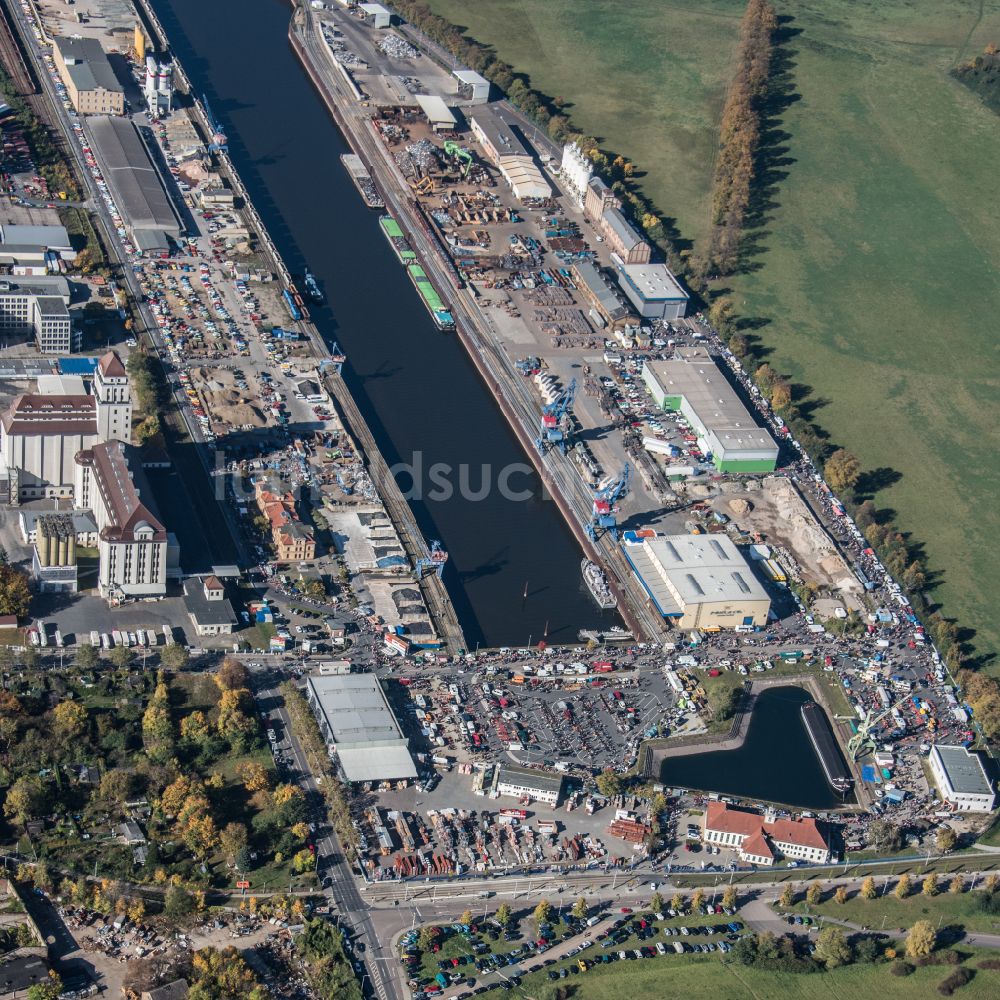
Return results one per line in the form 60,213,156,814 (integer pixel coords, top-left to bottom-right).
90,117,181,253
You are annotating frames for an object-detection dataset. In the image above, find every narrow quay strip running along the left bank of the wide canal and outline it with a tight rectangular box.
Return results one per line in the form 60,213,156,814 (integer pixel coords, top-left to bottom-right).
127,0,468,654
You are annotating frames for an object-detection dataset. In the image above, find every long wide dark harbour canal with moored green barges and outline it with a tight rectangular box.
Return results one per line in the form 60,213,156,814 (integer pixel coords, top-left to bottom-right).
154,0,620,647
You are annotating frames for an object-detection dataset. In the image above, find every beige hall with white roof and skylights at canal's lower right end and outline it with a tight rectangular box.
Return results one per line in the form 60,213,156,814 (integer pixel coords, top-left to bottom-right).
622,534,771,630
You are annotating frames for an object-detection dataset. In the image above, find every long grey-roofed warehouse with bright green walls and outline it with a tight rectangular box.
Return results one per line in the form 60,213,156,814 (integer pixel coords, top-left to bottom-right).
642,348,778,473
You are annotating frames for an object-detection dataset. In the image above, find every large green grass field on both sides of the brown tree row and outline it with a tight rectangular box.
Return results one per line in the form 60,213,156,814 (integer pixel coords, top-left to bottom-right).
430,0,1000,672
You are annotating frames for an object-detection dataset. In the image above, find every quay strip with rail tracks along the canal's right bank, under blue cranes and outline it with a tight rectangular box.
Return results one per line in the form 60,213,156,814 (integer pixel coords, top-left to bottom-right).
289,5,664,639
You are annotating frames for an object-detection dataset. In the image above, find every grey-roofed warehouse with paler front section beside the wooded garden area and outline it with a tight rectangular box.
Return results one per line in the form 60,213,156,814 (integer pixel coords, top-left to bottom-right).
306,674,417,782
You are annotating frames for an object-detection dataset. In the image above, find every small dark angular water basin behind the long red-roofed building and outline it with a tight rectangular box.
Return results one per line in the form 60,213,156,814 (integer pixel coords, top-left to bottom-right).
660,686,853,809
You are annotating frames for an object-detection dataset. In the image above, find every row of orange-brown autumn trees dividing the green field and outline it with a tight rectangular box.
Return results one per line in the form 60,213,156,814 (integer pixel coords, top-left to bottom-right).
705,0,778,274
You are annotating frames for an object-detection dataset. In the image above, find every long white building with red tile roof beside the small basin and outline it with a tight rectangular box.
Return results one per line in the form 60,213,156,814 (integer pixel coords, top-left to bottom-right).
703,802,831,865
